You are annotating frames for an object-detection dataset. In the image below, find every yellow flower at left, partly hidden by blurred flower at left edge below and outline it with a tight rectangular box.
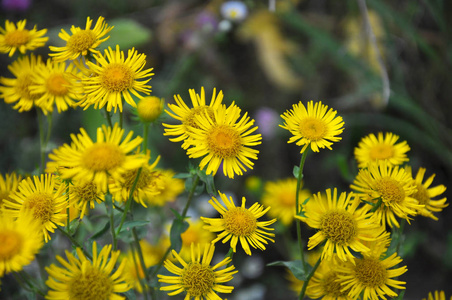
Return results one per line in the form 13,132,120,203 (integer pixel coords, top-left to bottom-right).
3,174,68,242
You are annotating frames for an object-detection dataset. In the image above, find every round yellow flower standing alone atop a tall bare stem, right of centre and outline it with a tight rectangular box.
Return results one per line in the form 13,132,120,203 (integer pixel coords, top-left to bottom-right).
279,101,344,153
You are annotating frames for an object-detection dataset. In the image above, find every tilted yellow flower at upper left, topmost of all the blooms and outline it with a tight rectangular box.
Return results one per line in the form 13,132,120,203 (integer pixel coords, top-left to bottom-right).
49,17,113,62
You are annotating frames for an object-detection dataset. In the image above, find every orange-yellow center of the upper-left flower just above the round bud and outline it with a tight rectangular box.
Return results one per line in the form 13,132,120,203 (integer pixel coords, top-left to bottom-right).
100,63,134,92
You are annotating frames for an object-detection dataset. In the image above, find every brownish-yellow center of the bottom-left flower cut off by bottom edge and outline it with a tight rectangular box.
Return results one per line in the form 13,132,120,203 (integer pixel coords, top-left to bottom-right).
69,262,113,300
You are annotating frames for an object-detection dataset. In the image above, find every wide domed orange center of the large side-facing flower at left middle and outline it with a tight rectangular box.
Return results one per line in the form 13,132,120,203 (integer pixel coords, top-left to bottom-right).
82,143,125,172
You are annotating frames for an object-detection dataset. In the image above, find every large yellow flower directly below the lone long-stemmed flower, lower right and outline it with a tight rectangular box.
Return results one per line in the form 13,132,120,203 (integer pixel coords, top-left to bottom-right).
295,189,384,261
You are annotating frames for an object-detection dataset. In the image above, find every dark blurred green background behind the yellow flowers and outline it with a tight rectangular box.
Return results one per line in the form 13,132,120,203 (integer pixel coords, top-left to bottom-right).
0,0,452,299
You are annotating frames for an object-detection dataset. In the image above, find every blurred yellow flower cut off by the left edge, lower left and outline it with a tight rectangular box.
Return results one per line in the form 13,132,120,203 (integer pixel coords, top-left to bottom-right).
0,212,43,277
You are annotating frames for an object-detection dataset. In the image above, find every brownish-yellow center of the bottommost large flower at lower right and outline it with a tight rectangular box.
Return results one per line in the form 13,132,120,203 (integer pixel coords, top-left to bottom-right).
355,258,388,287
